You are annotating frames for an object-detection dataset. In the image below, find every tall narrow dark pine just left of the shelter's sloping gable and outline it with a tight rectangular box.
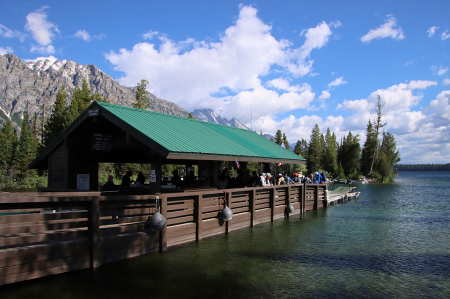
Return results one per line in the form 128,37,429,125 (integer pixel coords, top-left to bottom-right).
44,85,68,146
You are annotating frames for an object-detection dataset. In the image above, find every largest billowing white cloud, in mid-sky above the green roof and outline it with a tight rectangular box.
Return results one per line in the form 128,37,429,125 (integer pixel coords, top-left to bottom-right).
105,6,338,117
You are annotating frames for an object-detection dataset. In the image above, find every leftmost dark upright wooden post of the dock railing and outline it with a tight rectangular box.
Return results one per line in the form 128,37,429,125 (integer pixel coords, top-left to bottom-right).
88,196,100,269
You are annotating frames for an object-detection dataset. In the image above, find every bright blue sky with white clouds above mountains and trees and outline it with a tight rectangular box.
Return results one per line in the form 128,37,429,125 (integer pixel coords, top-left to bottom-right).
0,0,450,163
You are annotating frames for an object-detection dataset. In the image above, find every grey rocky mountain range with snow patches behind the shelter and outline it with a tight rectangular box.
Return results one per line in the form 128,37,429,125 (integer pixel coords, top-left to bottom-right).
0,54,189,127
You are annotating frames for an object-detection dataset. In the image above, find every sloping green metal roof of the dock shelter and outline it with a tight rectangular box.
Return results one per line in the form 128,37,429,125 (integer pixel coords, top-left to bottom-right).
96,102,306,163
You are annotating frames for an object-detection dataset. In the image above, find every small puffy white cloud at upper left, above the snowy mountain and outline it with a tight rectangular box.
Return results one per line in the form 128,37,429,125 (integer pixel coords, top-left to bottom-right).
25,6,59,46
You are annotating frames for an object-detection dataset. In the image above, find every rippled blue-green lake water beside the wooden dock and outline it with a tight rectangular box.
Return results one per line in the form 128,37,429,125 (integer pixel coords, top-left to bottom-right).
0,172,450,299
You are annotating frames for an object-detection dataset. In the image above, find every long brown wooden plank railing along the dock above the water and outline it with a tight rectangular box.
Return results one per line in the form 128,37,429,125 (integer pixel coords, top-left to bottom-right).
0,184,327,285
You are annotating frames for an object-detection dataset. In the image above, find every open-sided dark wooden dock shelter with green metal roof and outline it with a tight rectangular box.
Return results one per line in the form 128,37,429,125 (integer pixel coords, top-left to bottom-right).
29,102,306,194
